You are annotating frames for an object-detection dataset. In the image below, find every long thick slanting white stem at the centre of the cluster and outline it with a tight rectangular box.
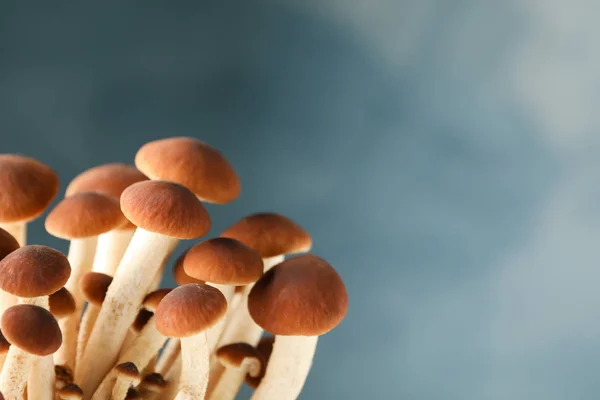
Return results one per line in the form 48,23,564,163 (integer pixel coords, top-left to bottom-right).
81,228,177,398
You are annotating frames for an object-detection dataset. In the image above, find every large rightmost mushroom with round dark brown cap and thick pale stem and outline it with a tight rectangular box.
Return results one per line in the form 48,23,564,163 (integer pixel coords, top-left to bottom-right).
248,254,348,400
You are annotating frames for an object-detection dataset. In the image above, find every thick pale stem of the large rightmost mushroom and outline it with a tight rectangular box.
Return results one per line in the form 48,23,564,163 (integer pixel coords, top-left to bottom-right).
252,335,318,400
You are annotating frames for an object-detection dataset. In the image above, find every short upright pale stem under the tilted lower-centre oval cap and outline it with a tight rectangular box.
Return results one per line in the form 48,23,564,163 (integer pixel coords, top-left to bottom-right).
176,331,210,400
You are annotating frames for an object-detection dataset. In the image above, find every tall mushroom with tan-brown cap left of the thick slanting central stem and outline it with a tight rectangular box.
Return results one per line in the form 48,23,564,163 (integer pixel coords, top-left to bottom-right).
45,192,126,369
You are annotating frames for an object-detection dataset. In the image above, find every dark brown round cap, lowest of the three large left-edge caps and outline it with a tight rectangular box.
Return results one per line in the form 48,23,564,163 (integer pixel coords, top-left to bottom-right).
0,304,62,356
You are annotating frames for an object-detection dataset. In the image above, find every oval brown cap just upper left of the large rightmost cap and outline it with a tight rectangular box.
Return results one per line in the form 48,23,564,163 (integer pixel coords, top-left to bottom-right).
183,238,263,285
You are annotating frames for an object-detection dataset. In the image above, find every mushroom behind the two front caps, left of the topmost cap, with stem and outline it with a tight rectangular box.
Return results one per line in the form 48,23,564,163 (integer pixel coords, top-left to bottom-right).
65,163,148,276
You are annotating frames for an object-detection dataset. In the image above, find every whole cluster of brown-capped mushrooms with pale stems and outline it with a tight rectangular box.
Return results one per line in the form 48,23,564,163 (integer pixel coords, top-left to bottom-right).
0,137,348,400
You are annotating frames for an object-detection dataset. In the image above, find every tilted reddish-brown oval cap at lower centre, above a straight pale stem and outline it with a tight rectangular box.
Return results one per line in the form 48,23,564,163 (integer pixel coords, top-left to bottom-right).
154,284,227,338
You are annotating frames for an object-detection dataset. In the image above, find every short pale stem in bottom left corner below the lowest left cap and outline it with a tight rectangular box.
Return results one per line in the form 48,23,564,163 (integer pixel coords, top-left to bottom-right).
0,346,33,400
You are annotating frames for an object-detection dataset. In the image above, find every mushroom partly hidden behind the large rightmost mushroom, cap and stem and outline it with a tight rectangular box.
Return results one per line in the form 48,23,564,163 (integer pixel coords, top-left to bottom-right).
213,213,312,360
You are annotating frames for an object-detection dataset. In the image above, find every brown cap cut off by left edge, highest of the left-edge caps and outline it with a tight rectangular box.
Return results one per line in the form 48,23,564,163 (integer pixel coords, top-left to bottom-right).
0,154,58,222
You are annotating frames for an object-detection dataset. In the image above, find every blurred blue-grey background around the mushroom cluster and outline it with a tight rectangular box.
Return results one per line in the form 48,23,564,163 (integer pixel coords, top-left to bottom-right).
0,0,600,400
